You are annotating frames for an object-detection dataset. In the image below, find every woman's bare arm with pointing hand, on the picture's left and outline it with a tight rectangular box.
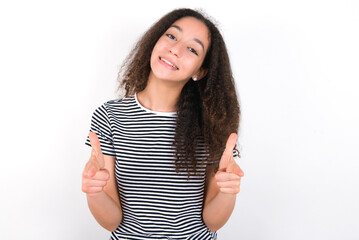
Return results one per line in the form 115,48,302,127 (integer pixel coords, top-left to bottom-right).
82,132,122,231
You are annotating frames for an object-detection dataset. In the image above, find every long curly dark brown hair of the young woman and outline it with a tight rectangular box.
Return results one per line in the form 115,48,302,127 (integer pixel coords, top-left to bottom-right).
118,8,240,175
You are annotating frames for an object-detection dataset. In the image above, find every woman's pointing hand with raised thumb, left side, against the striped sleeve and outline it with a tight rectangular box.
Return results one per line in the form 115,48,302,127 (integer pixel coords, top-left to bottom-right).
82,132,110,194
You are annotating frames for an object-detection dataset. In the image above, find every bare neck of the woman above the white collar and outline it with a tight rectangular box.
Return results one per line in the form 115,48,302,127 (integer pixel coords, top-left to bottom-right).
137,72,185,112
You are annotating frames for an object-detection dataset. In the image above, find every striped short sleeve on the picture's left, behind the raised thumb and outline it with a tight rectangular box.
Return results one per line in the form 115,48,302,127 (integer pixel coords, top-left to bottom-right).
85,104,116,156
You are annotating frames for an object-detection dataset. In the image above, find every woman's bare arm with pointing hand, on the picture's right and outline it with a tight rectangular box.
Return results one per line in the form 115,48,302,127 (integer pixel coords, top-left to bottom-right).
202,134,244,232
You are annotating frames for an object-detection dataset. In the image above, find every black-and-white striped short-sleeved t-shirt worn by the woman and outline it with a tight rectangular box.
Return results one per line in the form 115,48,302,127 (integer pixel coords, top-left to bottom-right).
86,95,233,240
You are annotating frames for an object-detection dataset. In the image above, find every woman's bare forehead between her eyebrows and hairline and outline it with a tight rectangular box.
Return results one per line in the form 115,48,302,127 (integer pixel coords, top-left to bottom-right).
172,17,210,48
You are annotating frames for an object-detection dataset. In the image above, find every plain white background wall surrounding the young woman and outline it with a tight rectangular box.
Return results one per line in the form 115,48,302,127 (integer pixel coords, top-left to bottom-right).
0,0,359,240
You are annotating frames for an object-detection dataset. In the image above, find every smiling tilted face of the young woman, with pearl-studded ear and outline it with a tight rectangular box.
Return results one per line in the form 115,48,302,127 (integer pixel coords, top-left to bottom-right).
150,17,210,83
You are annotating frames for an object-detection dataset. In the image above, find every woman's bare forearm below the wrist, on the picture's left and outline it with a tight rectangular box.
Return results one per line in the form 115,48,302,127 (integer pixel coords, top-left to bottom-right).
86,191,122,232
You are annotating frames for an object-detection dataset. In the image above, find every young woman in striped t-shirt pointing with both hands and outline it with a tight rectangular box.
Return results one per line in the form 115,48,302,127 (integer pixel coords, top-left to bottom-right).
82,9,243,240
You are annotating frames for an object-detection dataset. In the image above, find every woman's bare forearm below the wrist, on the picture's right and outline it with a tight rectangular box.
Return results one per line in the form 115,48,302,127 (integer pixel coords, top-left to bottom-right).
203,192,236,232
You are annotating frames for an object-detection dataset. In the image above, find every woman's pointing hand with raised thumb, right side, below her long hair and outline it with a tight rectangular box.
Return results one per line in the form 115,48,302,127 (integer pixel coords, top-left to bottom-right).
215,133,244,194
